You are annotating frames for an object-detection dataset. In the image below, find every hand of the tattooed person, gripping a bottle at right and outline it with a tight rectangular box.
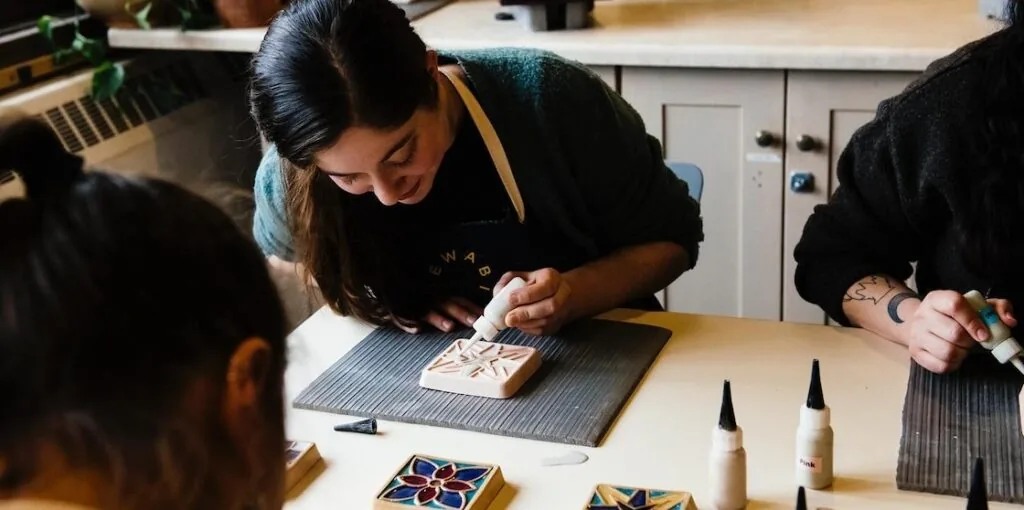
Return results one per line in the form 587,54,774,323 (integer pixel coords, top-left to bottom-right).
906,291,1017,374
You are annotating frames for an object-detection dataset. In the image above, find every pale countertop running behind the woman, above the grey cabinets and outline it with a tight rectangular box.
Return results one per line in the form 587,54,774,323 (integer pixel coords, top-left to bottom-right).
110,0,999,71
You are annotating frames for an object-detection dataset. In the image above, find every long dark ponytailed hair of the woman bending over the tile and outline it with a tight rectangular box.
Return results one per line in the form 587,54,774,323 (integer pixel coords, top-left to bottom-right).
250,0,437,325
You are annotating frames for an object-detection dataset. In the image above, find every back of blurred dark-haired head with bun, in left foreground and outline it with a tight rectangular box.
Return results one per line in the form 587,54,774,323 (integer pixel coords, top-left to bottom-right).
0,118,286,510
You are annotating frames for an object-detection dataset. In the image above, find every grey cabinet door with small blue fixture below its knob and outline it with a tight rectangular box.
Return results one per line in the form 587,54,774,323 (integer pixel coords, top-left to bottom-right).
782,72,918,324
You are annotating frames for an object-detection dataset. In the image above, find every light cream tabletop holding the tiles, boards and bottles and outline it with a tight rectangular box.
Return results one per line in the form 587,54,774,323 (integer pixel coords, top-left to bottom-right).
287,309,1019,510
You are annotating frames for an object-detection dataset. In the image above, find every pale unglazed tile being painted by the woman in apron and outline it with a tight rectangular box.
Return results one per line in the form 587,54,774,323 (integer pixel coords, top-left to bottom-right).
420,338,541,398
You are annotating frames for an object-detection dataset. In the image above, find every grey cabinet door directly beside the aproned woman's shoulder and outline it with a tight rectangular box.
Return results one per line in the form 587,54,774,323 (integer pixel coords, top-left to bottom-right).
621,68,785,321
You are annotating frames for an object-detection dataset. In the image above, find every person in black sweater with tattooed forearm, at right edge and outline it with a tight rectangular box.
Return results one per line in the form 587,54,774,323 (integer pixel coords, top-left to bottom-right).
795,0,1024,373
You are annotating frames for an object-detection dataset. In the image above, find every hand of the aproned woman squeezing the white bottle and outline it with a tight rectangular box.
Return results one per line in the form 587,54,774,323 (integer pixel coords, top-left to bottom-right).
494,267,572,335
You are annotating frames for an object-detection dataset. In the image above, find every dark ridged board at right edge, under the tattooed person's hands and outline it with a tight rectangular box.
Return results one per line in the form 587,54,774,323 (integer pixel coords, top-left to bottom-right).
896,352,1024,504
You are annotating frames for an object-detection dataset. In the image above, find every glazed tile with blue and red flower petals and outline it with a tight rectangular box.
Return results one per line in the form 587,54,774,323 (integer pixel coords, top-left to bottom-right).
374,455,505,510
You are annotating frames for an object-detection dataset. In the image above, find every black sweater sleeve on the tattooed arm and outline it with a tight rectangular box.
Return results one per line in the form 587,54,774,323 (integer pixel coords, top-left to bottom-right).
794,85,951,326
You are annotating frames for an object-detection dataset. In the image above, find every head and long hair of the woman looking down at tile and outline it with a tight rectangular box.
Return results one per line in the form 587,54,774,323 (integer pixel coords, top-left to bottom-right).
250,0,462,324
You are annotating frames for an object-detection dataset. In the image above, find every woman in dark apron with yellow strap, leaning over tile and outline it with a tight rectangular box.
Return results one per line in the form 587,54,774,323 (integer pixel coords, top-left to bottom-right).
250,0,703,334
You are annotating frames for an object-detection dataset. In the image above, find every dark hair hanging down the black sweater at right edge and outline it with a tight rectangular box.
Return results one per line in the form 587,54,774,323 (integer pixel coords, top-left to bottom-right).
958,0,1024,284
